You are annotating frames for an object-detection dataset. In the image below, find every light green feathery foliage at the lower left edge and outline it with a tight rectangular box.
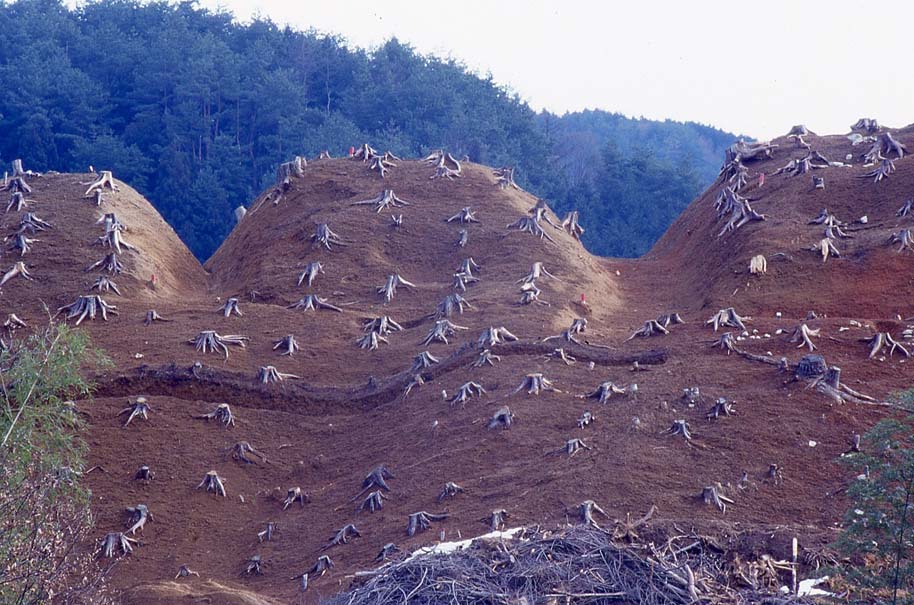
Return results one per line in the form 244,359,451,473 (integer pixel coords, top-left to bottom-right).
0,324,113,604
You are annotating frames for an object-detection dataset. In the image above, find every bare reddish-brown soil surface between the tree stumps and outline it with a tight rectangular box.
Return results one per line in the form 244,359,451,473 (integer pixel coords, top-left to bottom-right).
0,127,914,604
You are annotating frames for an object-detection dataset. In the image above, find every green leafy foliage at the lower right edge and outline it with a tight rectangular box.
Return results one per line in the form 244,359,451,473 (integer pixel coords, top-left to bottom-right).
838,408,914,605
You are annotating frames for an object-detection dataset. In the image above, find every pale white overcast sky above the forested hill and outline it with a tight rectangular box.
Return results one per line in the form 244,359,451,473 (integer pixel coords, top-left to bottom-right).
139,0,914,138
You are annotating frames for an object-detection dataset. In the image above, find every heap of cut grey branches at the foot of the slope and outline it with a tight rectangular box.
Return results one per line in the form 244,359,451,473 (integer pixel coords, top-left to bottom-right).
329,525,801,605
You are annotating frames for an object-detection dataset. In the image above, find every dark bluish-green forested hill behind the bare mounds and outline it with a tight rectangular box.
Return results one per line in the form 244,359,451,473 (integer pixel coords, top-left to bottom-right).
0,0,733,259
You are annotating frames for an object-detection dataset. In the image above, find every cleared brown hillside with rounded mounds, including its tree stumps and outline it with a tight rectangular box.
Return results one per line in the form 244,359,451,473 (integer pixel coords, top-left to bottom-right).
0,121,914,605
